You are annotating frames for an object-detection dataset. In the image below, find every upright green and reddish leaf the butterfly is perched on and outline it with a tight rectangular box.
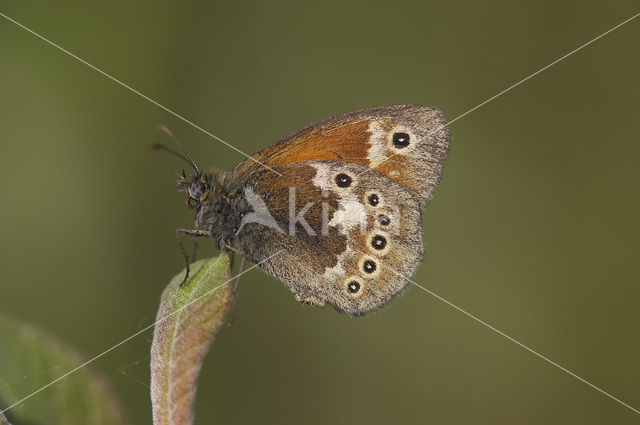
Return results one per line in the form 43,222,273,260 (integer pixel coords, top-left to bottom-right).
151,253,233,425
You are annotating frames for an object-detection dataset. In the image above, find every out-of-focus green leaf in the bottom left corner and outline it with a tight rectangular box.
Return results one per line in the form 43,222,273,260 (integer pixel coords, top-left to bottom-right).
0,316,129,425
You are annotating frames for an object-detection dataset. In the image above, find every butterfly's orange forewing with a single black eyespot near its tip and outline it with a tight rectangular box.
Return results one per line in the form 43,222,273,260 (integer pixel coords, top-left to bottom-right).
234,105,449,208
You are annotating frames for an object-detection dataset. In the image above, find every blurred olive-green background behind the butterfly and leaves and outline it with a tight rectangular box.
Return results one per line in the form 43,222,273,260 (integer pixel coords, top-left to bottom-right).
0,0,640,424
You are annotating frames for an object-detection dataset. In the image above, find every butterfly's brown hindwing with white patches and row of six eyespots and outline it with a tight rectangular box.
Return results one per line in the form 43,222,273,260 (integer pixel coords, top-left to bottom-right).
238,160,423,315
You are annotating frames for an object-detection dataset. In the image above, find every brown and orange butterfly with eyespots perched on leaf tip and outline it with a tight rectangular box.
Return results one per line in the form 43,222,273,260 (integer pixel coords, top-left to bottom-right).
165,105,450,315
